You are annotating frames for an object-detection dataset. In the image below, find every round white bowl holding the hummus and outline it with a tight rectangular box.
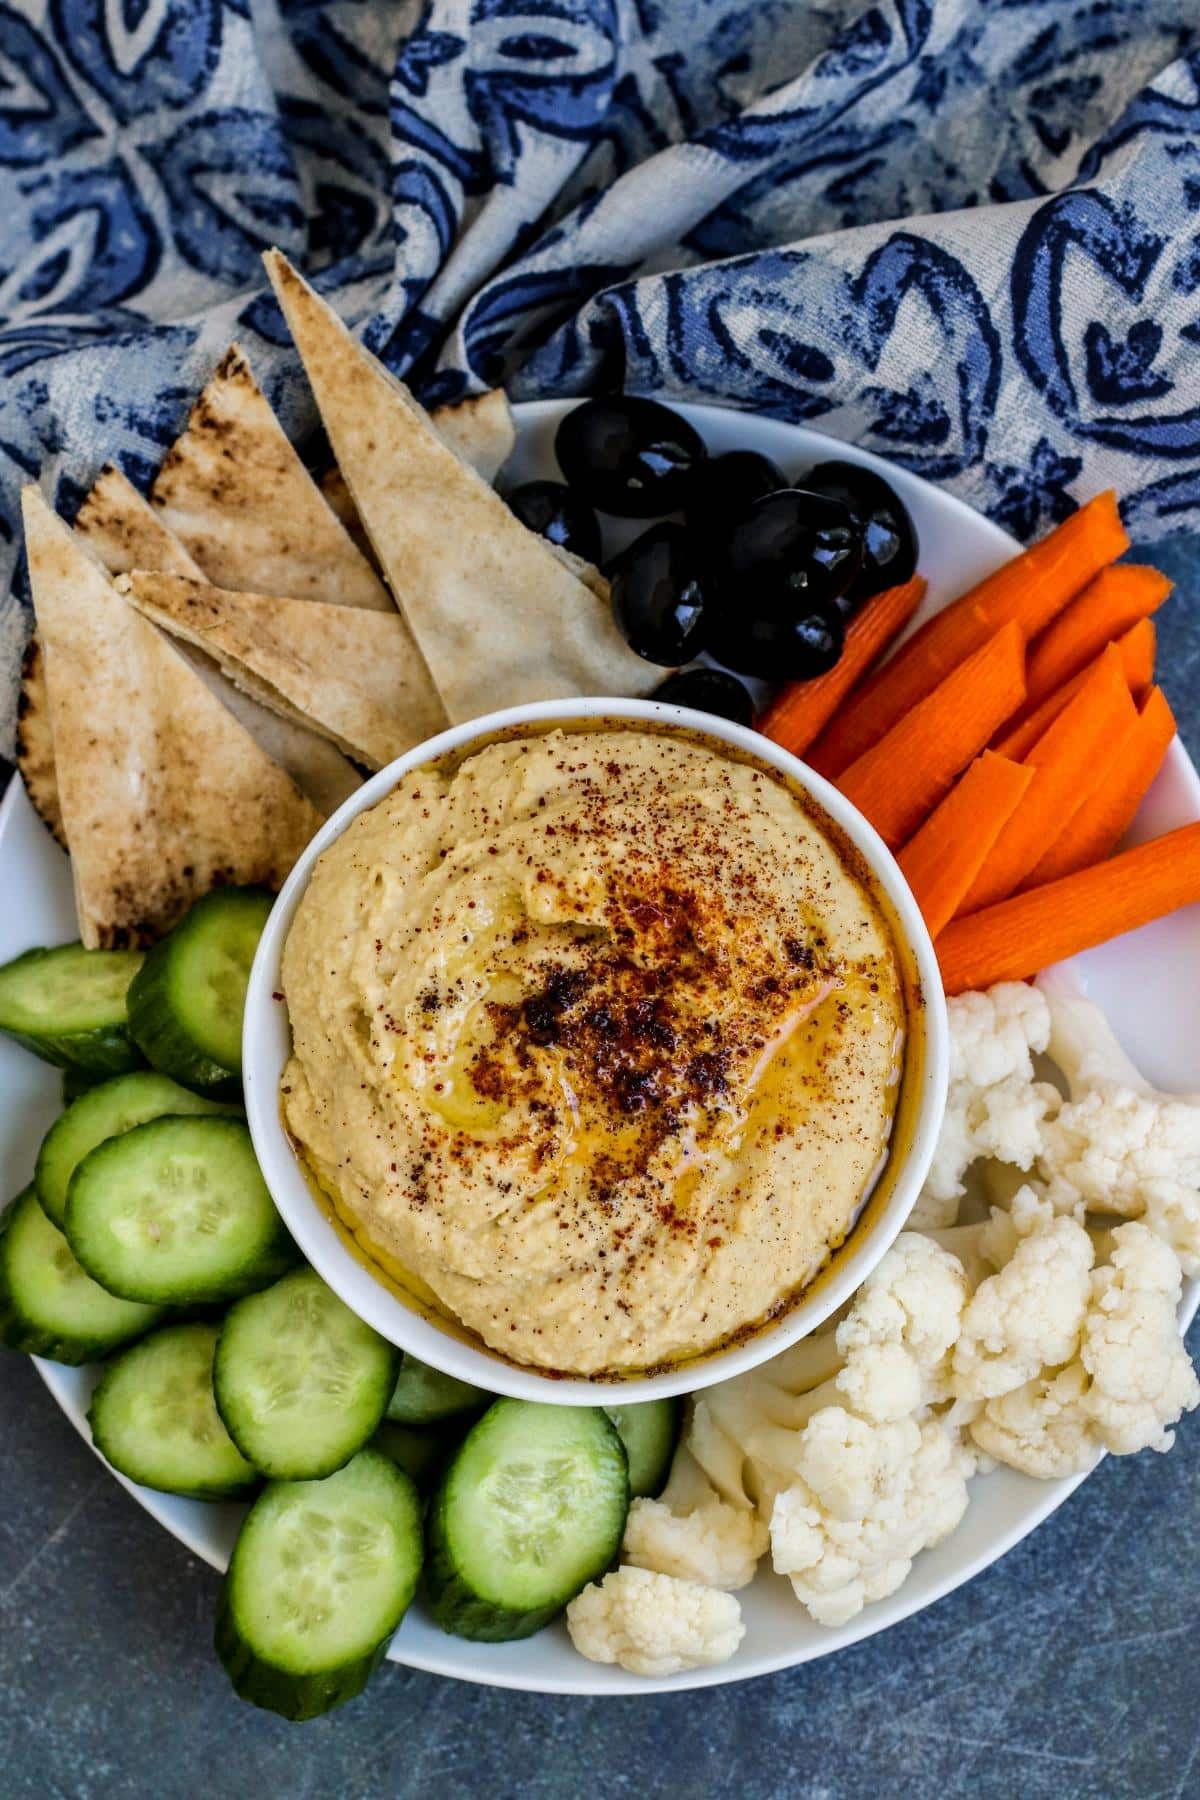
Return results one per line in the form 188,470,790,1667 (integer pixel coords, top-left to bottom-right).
243,698,948,1406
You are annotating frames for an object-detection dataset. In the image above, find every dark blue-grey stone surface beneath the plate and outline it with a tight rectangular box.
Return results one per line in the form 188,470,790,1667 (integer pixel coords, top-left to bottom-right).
0,538,1200,1800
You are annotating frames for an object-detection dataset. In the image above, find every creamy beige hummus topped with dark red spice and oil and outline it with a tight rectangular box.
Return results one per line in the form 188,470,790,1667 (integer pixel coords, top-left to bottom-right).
282,727,903,1373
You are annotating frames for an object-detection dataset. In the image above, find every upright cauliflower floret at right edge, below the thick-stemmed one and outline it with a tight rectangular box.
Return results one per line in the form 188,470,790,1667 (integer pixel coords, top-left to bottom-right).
1079,1224,1200,1456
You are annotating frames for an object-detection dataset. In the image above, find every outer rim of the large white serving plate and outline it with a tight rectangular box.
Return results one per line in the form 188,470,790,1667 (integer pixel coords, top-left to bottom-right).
11,396,1200,1699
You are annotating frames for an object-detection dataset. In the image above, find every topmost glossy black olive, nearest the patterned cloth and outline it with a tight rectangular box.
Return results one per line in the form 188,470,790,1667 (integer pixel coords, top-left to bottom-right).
554,394,705,518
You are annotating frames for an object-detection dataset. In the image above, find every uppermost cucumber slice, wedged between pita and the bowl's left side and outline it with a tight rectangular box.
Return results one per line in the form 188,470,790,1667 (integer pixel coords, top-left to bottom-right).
130,887,273,1096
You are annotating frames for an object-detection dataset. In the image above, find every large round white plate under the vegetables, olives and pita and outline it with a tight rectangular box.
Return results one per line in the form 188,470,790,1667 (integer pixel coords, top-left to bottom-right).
9,401,1200,1694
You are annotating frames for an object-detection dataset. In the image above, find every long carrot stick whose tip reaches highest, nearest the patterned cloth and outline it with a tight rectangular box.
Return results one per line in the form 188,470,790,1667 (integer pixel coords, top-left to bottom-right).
808,491,1130,778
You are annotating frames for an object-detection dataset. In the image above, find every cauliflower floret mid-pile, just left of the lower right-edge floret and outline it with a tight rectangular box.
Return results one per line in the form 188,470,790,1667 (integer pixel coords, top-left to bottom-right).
954,1186,1094,1400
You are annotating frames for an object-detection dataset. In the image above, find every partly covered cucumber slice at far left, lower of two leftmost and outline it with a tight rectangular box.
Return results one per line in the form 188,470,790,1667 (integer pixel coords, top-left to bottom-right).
0,1188,162,1363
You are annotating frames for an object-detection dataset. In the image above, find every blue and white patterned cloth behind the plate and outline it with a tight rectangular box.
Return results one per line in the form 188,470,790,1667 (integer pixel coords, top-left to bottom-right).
0,0,1200,743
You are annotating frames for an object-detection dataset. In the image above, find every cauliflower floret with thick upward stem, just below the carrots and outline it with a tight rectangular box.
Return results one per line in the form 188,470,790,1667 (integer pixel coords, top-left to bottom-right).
1038,981,1200,1276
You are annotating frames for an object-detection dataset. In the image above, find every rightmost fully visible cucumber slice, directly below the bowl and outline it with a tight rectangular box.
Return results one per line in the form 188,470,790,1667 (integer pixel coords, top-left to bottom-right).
425,1400,630,1643
